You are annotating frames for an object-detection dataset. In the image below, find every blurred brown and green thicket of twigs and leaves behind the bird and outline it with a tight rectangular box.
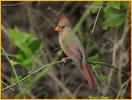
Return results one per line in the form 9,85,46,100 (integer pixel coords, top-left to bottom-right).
2,1,131,98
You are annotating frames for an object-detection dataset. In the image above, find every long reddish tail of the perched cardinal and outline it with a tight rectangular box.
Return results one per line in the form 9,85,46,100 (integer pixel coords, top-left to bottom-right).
82,59,95,89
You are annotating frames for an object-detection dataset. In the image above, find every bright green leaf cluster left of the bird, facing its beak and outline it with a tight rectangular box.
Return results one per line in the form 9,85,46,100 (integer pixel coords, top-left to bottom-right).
9,27,42,69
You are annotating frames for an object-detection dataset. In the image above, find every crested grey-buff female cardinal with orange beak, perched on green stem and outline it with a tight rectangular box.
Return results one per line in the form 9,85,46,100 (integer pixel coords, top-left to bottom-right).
55,15,95,89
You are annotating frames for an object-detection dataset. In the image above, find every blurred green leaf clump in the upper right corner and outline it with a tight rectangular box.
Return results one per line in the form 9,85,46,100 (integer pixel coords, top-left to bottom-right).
101,2,126,30
